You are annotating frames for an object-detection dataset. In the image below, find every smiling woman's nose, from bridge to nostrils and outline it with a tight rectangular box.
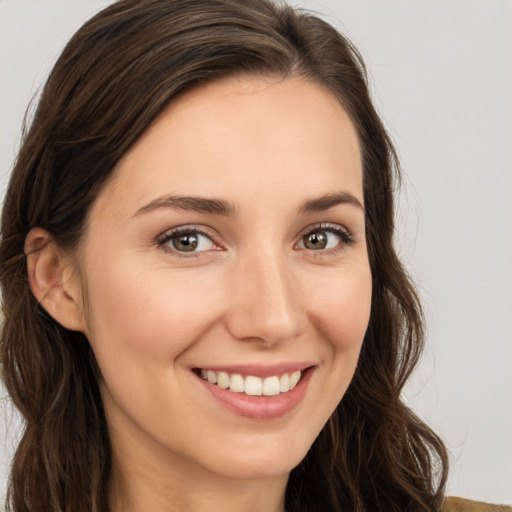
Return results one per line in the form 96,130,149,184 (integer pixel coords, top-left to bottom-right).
226,253,307,346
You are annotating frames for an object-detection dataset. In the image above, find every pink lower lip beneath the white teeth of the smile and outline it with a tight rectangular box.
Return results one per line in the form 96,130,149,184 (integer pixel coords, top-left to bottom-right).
194,368,313,420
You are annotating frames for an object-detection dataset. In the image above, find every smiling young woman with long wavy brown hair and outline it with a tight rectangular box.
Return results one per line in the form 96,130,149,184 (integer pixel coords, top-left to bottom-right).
0,0,508,512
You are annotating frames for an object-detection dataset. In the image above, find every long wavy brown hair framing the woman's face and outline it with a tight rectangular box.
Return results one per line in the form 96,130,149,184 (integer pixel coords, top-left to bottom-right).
0,0,447,512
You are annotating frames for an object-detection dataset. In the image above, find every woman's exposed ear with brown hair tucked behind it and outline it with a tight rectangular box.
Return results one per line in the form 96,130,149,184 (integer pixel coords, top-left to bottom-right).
25,228,85,332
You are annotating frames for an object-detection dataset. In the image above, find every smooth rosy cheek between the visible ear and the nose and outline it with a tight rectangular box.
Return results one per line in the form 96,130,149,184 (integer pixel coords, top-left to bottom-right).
83,261,225,366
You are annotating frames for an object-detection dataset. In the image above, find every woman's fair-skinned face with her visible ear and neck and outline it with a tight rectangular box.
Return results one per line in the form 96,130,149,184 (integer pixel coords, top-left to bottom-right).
27,77,371,512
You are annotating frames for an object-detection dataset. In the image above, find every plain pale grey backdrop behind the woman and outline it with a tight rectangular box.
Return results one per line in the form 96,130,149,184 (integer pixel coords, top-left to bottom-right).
0,0,512,504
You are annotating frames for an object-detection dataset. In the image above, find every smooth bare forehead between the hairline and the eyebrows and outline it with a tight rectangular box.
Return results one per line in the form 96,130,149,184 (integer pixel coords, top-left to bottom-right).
93,77,363,218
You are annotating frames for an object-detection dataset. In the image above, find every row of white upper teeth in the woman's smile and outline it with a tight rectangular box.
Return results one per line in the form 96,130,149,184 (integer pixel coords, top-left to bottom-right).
196,370,302,396
